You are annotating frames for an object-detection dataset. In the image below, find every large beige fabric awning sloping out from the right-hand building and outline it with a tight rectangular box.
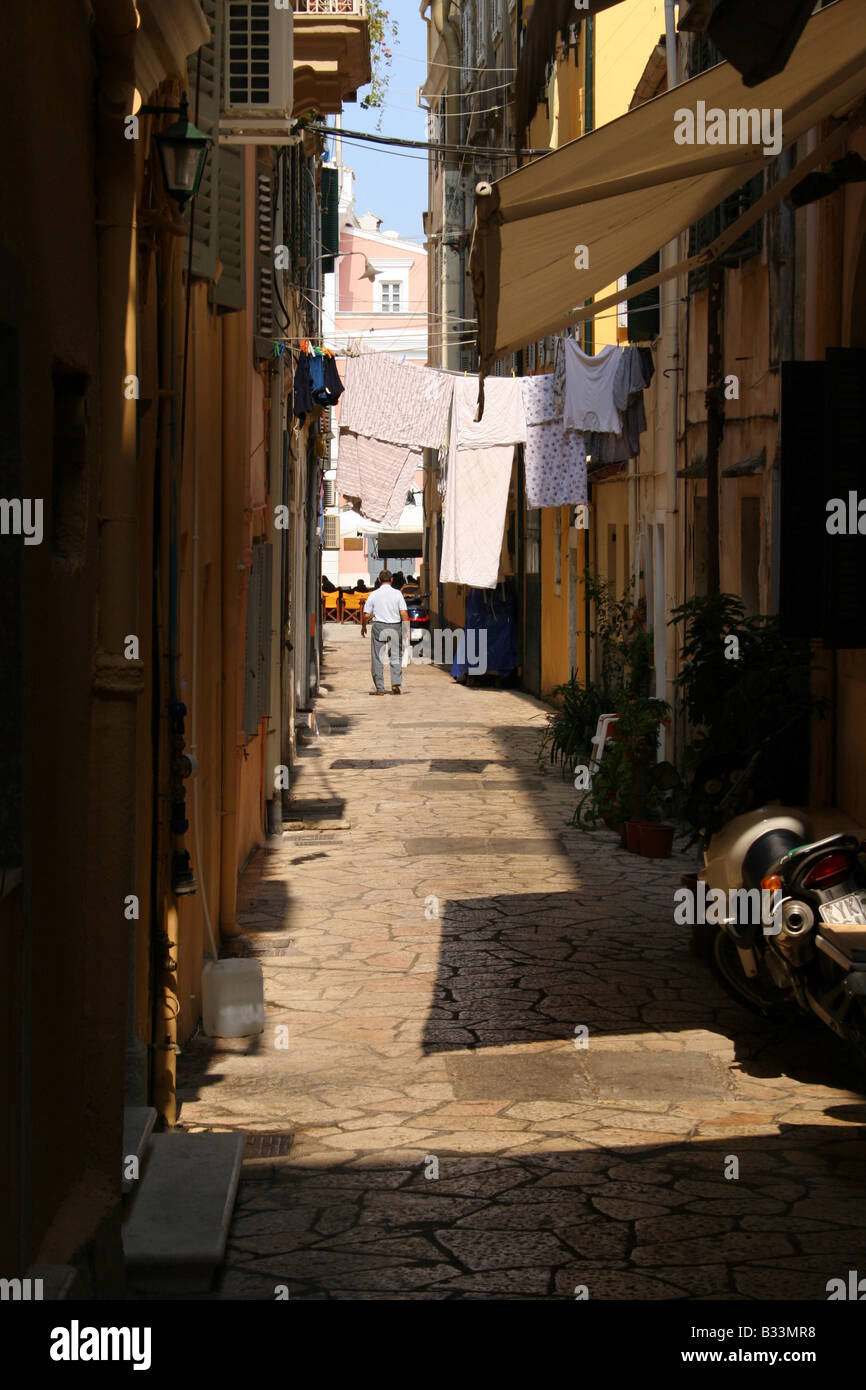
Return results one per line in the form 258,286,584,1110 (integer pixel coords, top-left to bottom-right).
470,0,866,373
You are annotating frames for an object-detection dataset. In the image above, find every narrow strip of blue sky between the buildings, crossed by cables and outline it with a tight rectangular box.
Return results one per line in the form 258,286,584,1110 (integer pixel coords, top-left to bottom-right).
326,0,427,242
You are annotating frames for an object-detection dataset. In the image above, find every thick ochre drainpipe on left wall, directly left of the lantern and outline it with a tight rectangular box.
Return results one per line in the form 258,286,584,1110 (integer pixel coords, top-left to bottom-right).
90,0,143,1162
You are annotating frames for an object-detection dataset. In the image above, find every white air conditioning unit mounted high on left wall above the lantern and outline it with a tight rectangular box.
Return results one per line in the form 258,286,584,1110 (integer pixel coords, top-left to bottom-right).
220,0,300,145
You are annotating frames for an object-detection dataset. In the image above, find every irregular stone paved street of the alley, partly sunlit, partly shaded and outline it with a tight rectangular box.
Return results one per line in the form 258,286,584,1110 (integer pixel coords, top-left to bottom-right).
179,626,866,1300
